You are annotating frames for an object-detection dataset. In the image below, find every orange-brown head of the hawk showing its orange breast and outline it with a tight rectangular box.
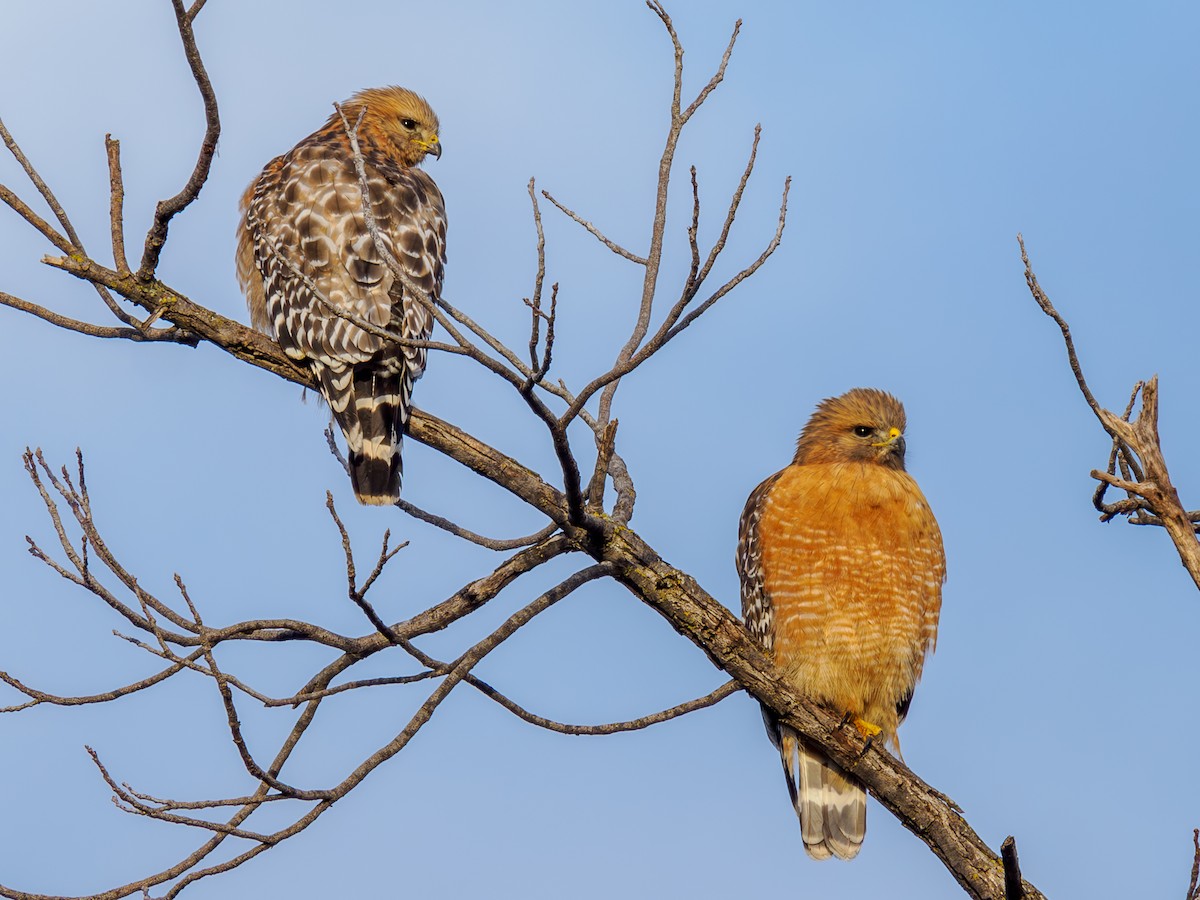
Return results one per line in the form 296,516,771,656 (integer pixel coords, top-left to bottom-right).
792,388,905,470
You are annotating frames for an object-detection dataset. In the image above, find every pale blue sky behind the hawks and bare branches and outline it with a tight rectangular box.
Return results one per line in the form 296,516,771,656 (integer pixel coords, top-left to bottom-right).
0,0,1200,900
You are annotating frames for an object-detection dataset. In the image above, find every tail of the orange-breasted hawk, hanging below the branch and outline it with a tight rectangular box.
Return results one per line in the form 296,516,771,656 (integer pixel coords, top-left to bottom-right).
776,725,866,859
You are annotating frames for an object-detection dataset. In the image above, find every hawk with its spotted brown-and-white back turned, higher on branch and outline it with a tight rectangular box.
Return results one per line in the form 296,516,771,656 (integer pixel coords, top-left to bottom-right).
238,88,446,505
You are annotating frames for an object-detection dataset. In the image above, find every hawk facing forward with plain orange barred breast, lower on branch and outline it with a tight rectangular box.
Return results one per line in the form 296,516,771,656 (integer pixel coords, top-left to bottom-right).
737,388,946,859
